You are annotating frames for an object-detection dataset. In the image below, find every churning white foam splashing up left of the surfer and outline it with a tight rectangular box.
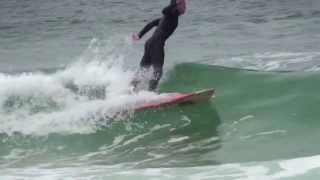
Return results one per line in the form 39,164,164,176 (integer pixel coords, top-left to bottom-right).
0,40,162,135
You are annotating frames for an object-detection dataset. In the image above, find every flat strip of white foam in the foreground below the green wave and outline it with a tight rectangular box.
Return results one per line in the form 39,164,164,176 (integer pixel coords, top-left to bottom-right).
0,154,320,180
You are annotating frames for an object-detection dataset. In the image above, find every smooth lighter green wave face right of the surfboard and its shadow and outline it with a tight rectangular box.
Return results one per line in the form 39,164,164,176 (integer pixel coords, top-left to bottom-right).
162,64,319,163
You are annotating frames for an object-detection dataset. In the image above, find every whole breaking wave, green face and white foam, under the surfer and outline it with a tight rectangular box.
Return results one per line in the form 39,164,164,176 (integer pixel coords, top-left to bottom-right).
0,62,320,179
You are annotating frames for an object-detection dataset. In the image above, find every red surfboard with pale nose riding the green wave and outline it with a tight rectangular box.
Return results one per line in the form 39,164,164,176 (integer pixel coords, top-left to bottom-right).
135,89,215,112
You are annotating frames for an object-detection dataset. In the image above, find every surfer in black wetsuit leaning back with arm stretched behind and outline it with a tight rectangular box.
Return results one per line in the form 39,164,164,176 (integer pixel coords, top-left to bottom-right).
132,0,186,90
